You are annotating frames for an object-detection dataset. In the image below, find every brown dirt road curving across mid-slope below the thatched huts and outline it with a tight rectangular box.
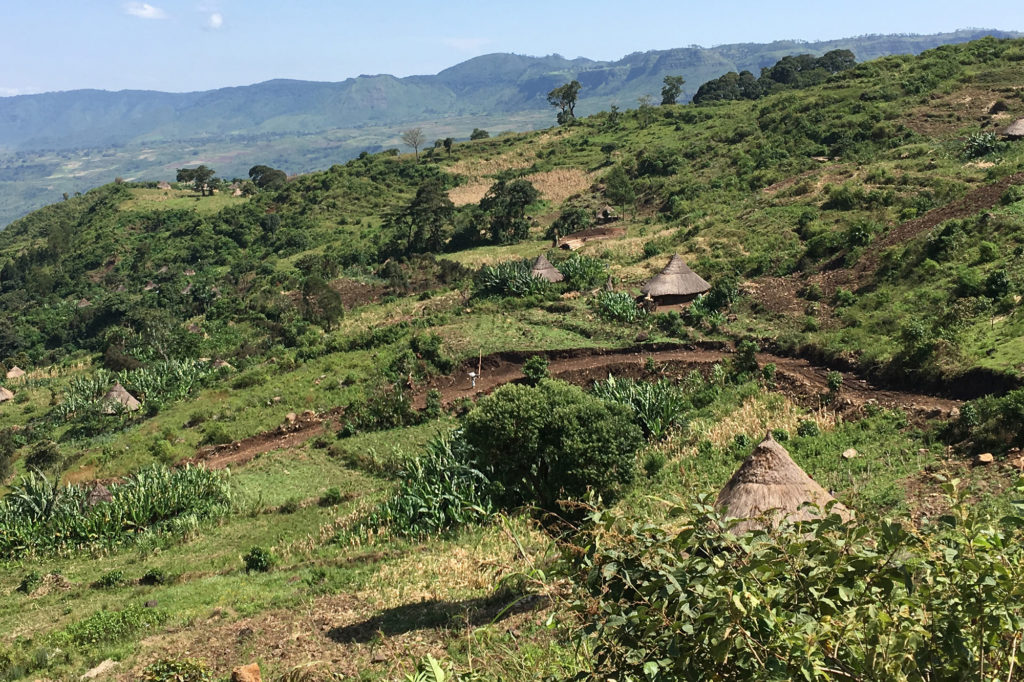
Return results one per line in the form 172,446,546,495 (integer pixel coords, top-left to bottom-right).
413,348,959,419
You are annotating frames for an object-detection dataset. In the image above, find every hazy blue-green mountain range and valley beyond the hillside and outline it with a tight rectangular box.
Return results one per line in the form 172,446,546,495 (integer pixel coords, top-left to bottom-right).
0,29,1024,225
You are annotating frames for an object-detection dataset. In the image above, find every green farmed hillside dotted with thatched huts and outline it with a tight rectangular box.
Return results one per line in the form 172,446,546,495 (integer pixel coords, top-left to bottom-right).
0,38,1024,680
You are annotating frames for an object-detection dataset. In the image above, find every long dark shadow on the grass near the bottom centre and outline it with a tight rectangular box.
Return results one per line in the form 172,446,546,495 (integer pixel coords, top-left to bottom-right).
327,592,549,644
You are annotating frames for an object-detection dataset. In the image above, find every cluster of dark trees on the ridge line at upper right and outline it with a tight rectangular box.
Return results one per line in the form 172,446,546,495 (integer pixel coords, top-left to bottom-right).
693,50,857,104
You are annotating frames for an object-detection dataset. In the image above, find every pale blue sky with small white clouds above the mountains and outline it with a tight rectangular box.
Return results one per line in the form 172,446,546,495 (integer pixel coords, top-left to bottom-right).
0,0,1024,95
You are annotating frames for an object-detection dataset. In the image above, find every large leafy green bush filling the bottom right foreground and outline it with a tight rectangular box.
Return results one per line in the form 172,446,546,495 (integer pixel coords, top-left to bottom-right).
565,481,1024,680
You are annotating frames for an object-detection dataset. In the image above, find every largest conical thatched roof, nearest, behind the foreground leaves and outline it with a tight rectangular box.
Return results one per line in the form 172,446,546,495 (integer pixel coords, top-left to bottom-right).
715,434,852,532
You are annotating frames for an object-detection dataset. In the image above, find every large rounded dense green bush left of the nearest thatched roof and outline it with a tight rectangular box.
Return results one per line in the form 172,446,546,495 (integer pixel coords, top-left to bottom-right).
464,379,642,510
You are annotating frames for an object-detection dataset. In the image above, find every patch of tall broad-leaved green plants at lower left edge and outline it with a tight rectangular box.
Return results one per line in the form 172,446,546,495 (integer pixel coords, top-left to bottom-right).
0,465,230,558
